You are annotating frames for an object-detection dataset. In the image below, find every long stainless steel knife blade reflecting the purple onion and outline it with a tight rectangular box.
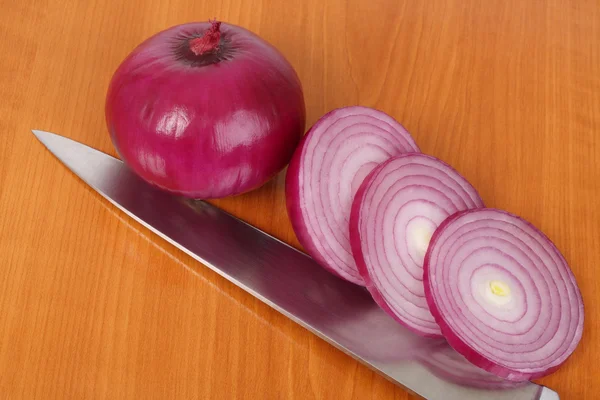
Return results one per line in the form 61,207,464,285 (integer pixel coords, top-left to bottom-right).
33,130,559,400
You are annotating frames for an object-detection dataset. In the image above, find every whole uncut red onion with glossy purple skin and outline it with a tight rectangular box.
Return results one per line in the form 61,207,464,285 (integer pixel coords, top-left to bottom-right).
105,22,306,199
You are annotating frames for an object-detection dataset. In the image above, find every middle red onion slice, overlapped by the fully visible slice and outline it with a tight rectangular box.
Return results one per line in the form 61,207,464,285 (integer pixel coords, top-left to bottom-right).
350,153,483,337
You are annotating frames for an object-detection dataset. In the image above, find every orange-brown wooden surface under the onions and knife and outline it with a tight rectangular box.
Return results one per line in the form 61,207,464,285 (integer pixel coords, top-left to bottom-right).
0,0,600,400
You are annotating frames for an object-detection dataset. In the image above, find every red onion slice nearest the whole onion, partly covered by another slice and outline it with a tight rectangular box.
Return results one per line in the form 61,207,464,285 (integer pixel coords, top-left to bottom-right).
286,106,419,285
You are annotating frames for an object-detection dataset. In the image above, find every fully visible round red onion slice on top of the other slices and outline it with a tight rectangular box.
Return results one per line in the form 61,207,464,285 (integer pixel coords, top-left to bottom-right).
424,209,583,381
